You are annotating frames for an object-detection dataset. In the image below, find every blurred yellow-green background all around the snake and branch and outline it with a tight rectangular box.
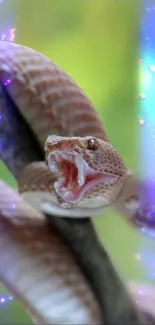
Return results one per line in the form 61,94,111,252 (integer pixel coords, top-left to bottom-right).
0,0,155,324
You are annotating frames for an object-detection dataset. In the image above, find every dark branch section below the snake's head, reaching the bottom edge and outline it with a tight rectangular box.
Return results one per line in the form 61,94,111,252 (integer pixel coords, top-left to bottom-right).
47,216,152,325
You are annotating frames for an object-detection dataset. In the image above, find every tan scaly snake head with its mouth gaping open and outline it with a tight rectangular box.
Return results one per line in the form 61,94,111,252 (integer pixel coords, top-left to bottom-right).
45,135,128,207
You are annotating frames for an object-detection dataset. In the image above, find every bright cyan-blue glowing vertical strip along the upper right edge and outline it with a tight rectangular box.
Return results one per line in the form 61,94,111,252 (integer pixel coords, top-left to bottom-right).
138,4,155,179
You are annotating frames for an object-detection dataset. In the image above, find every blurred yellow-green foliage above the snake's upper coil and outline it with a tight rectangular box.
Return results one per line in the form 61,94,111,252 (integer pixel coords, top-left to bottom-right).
17,0,139,163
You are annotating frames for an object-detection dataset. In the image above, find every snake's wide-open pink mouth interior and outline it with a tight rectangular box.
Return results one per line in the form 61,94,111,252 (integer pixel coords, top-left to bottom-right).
47,151,116,204
